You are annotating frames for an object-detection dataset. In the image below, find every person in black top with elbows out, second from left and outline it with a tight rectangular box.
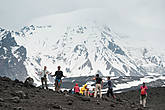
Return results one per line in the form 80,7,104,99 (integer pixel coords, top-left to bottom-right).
52,66,65,91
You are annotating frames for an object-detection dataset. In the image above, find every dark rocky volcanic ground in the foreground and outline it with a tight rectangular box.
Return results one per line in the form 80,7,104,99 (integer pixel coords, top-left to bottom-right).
0,77,165,110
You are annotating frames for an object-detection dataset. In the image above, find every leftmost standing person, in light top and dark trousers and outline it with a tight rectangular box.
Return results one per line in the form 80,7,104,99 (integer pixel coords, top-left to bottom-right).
36,66,51,89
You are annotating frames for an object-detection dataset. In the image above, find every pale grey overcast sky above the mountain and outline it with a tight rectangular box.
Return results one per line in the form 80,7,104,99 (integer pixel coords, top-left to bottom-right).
0,0,165,45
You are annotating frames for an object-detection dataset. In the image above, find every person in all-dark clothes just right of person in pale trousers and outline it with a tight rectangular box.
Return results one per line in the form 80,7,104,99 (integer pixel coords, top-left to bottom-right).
104,77,116,98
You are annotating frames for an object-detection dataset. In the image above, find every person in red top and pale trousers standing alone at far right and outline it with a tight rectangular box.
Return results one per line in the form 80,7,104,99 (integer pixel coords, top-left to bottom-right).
140,82,148,107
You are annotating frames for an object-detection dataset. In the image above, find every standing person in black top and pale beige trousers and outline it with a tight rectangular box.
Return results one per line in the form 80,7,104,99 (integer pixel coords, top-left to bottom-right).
93,74,103,98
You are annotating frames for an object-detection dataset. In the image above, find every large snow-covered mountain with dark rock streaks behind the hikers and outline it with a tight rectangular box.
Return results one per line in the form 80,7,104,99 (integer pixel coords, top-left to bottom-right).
0,10,165,84
